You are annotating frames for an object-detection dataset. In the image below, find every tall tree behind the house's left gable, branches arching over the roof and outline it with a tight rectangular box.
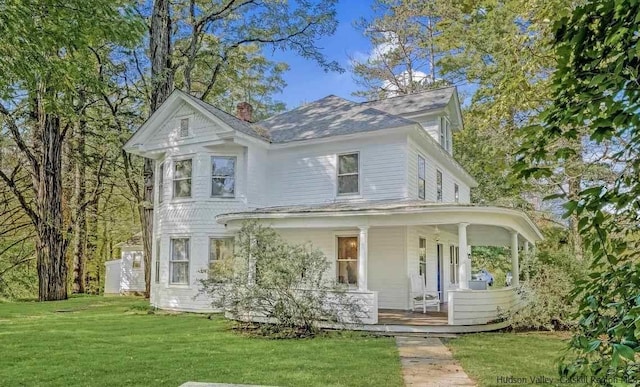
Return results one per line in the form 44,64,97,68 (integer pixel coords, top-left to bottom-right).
134,0,342,296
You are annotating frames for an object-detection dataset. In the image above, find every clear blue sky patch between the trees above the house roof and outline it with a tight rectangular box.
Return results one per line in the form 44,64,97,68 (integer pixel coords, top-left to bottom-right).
269,0,372,109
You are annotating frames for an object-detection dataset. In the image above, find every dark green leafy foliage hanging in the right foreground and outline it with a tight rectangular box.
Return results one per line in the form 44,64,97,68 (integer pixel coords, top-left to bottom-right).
518,0,640,385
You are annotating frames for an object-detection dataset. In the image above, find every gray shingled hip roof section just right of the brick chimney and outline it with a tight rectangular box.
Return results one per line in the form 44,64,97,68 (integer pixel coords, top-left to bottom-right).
256,95,415,143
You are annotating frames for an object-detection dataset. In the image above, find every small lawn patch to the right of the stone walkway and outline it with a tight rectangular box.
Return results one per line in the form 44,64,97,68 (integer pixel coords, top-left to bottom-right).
447,332,577,386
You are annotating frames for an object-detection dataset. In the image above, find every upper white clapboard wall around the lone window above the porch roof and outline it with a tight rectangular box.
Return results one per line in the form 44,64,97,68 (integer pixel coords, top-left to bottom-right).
268,136,407,206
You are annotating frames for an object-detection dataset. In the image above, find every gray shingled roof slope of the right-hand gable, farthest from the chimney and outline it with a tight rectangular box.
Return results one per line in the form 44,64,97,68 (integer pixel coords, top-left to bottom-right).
363,86,455,115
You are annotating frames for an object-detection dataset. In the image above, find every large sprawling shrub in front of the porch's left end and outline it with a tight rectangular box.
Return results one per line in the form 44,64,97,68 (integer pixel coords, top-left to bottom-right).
201,222,363,337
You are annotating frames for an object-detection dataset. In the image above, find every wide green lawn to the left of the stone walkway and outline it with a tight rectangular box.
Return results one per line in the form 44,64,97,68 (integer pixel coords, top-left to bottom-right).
0,297,402,386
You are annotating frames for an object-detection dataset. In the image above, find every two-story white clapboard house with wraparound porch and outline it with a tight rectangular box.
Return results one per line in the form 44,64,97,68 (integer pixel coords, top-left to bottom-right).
125,87,542,334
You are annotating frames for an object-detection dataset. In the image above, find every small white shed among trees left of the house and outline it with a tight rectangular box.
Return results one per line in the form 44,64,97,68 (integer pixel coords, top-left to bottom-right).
104,234,144,295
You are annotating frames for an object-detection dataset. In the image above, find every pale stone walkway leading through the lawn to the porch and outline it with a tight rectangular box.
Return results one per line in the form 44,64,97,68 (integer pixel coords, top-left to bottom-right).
396,336,476,387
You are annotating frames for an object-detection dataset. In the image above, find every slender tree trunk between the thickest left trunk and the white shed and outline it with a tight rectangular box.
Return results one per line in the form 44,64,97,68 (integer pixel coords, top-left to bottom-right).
72,120,87,293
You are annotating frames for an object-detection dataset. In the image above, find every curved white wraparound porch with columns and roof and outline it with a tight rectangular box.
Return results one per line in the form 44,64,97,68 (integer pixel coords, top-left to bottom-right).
218,201,542,333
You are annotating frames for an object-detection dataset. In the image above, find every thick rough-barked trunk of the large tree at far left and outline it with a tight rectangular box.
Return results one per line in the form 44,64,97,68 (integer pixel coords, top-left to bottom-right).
33,114,67,301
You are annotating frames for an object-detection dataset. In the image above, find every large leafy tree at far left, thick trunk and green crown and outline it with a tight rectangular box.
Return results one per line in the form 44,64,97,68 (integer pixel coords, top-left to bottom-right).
0,0,137,301
